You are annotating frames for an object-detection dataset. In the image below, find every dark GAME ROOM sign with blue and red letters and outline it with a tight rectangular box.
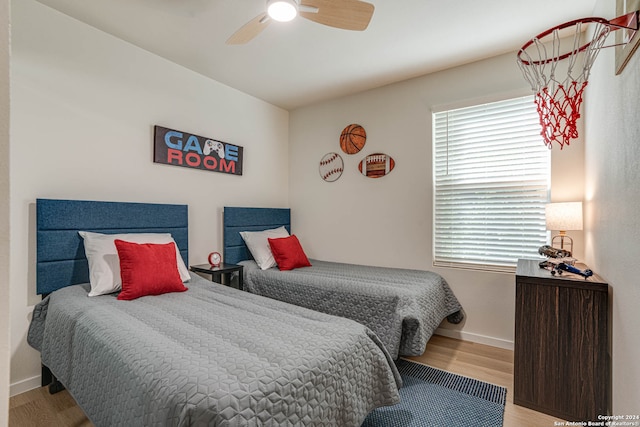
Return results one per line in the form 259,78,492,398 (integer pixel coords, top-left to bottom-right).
153,126,243,175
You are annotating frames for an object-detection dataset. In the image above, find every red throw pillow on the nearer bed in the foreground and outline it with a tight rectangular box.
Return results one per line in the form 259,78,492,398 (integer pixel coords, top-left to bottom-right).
114,239,187,300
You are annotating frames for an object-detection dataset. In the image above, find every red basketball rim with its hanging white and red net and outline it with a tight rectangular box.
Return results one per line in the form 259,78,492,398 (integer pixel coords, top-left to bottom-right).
518,18,611,149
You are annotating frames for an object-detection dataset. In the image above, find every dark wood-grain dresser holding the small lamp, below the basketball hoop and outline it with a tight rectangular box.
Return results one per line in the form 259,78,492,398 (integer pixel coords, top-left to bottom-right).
513,259,611,422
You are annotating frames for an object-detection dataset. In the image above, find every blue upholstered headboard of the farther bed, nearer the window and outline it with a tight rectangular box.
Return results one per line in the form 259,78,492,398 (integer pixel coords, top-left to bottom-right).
223,207,291,264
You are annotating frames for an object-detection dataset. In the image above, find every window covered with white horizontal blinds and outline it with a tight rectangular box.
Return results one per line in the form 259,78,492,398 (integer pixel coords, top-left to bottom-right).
433,96,550,271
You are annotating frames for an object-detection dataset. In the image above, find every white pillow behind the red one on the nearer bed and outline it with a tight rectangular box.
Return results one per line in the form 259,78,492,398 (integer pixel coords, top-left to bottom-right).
78,231,191,297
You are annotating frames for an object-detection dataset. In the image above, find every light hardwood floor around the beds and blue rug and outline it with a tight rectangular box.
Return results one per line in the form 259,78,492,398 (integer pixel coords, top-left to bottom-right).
9,335,562,427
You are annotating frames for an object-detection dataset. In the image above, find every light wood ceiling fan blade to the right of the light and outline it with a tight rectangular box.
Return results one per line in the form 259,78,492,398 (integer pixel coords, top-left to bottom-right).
300,0,375,31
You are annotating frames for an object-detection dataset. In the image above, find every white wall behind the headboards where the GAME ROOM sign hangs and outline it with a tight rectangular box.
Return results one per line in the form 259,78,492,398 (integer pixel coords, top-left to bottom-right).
9,0,288,394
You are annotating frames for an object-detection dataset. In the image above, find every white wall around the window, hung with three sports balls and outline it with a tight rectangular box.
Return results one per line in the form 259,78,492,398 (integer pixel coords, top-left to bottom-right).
290,51,583,348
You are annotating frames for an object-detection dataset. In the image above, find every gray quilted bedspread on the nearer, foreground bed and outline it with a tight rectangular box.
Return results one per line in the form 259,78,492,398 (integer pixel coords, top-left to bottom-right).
28,277,401,427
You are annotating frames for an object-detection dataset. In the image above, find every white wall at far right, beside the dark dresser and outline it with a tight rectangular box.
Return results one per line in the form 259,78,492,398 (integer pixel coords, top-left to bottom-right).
584,0,640,415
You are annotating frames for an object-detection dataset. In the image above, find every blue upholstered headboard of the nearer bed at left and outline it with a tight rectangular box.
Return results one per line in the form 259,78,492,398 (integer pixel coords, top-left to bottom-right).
36,199,189,294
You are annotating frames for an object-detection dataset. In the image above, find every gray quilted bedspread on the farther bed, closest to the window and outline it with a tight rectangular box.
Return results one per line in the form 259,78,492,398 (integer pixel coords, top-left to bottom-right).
241,260,463,359
